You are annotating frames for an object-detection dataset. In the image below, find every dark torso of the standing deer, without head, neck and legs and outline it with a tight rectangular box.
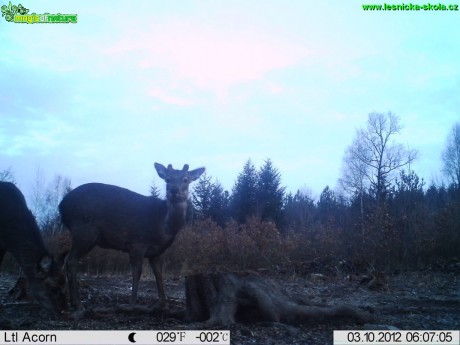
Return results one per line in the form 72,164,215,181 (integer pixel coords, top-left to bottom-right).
59,183,175,257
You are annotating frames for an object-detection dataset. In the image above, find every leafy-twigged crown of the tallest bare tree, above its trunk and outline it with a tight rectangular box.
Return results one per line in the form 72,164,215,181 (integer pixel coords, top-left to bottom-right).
340,112,417,201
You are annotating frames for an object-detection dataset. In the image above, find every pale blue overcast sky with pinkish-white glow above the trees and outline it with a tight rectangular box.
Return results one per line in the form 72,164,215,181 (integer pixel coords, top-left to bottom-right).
0,0,460,196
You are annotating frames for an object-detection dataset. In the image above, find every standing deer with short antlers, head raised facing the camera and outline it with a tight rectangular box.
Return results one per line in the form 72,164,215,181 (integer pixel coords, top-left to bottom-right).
59,163,205,310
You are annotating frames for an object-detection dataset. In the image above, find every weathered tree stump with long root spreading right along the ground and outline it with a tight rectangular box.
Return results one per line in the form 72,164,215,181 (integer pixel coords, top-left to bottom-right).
185,272,369,326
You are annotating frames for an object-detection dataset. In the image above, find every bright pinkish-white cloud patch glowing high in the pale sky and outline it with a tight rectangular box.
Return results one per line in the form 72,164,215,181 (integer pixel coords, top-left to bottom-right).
102,20,309,94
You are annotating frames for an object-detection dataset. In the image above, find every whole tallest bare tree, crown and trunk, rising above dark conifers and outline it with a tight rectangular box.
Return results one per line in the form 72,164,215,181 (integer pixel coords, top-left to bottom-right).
339,112,417,257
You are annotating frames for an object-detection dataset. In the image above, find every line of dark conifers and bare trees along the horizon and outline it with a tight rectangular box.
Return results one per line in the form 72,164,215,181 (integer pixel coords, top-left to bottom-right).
0,113,460,269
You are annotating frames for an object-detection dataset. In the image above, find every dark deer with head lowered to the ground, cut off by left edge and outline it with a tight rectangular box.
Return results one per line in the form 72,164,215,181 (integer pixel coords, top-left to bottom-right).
0,182,66,313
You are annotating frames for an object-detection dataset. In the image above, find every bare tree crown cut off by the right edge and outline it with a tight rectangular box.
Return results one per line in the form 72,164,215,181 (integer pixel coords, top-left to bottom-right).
442,122,460,187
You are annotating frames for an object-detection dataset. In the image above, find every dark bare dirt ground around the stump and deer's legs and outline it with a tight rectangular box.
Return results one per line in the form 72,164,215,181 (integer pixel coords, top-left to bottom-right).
0,271,460,345
